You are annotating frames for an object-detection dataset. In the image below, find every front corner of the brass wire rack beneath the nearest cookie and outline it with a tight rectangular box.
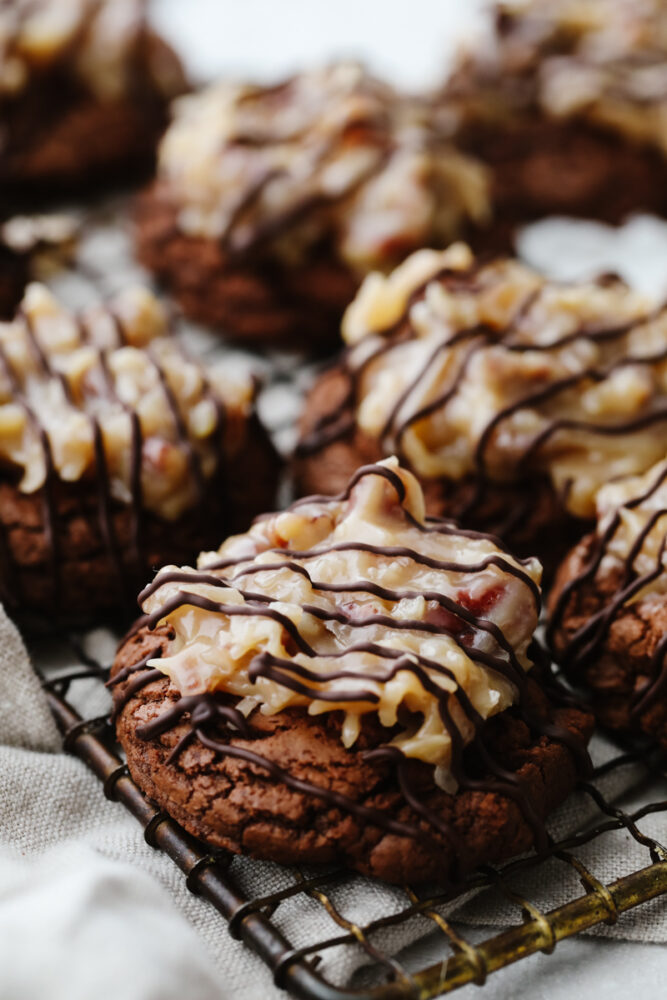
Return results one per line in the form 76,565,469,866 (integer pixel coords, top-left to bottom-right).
32,632,667,1000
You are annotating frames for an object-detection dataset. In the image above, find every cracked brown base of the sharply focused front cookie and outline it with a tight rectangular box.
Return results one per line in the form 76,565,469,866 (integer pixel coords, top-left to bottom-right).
112,629,591,883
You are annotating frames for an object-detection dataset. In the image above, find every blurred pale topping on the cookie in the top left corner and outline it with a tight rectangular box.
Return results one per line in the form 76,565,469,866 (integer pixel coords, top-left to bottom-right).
0,0,181,104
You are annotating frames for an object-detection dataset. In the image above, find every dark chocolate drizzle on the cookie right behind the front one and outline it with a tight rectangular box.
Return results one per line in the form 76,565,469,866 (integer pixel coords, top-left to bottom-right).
296,260,667,534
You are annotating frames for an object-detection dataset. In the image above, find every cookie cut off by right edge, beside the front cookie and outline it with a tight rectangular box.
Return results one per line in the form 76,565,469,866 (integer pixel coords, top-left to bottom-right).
548,461,667,748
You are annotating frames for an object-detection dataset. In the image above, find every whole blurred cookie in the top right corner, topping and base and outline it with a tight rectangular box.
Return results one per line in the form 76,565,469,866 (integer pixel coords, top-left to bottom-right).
440,0,667,226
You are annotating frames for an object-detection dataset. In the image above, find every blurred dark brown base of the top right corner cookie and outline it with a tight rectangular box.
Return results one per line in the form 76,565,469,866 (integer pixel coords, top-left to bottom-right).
448,114,667,230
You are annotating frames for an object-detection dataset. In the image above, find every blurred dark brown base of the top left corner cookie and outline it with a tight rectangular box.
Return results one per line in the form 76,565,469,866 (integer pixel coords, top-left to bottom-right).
0,35,185,205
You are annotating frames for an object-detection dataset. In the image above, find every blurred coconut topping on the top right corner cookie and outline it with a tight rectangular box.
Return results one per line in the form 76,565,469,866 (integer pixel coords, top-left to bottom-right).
451,0,667,152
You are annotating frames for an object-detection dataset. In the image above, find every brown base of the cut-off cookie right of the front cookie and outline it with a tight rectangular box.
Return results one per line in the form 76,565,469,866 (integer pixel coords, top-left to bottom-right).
548,535,667,749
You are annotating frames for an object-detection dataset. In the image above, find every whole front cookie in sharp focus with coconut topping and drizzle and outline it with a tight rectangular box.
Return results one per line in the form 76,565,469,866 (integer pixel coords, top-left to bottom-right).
110,459,591,883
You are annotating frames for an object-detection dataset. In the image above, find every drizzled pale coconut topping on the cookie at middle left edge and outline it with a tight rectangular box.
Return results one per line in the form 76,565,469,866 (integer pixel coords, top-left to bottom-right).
0,284,253,520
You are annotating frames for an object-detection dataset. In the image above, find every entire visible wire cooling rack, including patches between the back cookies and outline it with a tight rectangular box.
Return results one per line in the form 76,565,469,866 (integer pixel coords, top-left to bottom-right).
9,191,667,1000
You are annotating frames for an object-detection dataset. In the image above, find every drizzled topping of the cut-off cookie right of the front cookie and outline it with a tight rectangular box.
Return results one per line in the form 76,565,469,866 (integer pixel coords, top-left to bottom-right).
548,459,667,717
